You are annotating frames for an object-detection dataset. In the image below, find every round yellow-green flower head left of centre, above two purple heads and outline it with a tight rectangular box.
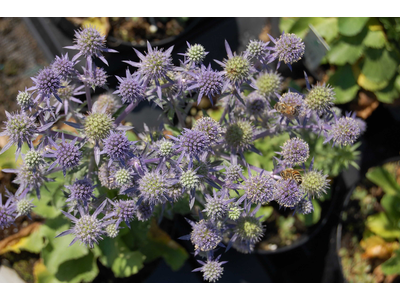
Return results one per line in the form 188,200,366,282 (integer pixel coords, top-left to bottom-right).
85,112,113,141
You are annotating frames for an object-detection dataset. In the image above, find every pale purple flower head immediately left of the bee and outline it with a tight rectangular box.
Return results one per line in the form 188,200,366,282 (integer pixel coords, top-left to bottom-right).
238,172,275,204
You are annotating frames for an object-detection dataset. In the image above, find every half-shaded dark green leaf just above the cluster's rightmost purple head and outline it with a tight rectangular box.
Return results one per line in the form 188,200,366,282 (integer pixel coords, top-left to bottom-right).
328,64,359,104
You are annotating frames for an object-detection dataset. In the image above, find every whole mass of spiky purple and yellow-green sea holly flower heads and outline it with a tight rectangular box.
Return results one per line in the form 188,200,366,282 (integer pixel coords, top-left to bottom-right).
0,27,363,282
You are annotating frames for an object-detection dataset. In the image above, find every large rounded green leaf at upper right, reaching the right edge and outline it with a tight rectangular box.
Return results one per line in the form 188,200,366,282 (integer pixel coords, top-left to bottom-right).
361,48,399,84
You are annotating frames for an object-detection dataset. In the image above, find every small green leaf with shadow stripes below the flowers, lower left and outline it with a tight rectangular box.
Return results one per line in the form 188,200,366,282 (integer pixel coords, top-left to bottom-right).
111,251,145,277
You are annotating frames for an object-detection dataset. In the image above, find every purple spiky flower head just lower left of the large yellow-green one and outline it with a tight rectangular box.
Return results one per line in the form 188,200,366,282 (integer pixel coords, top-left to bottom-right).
45,134,82,176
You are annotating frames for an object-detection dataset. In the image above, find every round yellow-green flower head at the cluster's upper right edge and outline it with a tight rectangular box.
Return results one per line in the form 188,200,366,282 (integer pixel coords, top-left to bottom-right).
304,83,335,113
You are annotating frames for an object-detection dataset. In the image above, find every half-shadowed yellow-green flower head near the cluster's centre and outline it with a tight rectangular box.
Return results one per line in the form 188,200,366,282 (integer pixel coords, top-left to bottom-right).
224,120,254,153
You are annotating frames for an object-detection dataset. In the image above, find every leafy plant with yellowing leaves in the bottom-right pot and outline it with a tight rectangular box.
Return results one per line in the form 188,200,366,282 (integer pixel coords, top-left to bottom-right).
339,162,400,282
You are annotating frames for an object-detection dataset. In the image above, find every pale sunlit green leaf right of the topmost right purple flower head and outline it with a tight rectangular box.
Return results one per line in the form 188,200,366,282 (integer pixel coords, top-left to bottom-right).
327,29,368,66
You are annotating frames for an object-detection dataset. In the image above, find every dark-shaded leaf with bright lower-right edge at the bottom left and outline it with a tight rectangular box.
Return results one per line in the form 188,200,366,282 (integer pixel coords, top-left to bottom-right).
54,252,99,282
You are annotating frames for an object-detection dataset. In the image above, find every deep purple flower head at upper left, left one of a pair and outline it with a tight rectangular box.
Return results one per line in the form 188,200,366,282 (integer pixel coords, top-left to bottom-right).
28,67,62,102
